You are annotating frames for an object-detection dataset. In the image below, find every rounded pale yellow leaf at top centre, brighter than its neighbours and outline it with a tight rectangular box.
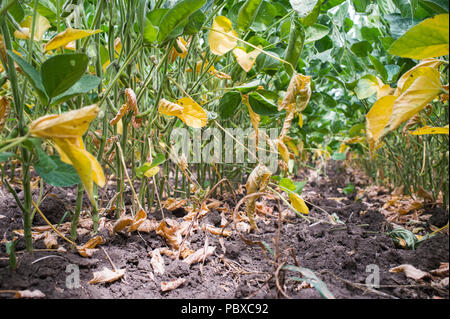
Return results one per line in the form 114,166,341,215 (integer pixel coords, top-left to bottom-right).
209,16,237,55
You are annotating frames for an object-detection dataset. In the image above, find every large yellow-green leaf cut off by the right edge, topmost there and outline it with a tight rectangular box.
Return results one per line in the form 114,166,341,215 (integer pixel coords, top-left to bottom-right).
389,14,449,60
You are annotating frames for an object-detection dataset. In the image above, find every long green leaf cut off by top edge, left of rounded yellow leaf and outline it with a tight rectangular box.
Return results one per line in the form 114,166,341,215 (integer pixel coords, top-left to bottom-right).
157,0,206,43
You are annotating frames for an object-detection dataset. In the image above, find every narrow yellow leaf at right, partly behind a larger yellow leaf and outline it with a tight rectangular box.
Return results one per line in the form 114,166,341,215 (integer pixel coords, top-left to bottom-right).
366,95,396,151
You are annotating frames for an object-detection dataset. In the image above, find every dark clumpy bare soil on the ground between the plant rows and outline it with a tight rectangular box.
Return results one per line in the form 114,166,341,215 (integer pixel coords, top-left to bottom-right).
0,163,449,299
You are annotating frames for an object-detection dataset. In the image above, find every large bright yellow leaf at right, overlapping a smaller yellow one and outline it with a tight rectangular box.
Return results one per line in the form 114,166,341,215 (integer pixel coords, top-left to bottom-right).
383,67,441,135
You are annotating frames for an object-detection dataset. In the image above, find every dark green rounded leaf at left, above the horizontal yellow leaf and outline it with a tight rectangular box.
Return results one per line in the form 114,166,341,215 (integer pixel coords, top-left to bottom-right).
41,53,89,99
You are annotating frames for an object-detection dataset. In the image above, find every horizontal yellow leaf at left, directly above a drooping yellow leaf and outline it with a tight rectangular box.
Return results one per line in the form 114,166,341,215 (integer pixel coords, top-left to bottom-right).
30,104,100,138
